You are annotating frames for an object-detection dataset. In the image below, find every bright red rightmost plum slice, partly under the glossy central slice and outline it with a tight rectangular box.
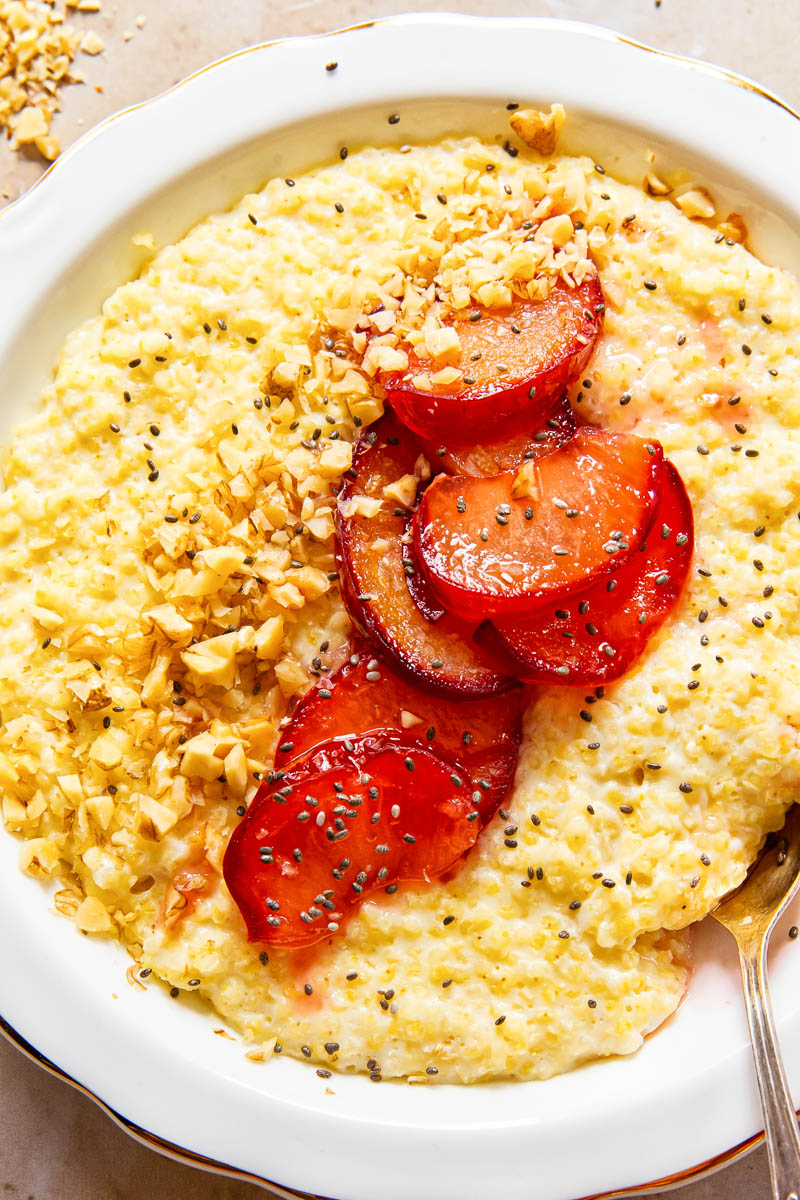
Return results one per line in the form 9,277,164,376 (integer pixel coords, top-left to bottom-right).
494,462,693,684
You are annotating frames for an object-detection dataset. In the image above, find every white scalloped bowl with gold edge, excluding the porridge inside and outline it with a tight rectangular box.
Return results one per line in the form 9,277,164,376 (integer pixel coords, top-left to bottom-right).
0,16,800,1200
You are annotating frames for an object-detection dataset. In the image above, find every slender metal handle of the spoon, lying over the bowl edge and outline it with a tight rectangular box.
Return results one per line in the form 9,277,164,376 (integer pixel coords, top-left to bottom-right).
739,935,800,1200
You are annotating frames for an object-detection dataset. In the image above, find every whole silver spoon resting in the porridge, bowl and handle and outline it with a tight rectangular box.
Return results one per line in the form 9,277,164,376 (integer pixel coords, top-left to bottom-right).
711,804,800,1200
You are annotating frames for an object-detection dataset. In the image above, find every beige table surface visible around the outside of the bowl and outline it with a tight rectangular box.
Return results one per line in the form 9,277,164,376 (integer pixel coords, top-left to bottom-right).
0,0,800,1200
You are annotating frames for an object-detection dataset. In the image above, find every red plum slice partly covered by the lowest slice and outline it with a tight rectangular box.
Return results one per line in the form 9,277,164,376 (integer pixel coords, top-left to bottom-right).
275,646,527,823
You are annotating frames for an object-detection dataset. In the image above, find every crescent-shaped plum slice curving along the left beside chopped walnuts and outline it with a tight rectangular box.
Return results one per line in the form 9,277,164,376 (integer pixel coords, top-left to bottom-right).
336,413,513,696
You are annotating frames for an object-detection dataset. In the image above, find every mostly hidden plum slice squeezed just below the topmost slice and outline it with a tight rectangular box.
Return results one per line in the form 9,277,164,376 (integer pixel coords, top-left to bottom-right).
423,396,577,475
